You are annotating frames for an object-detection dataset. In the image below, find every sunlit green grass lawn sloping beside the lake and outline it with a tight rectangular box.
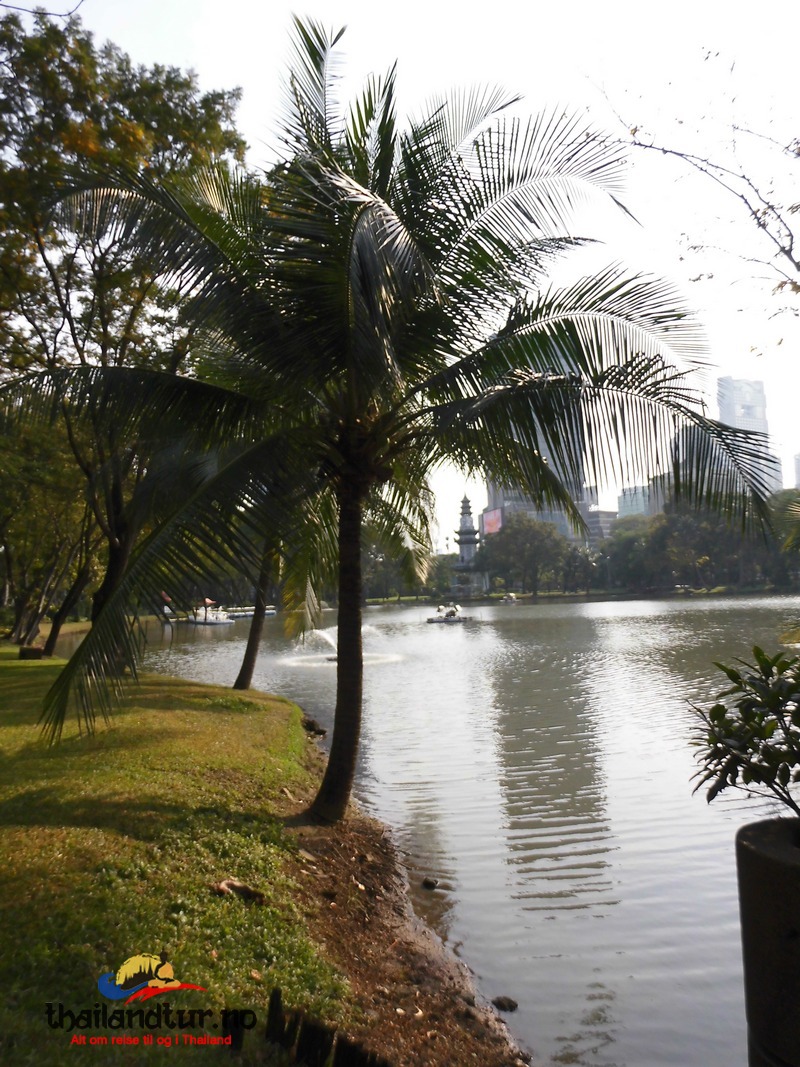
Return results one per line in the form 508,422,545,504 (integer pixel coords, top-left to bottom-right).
0,648,347,1065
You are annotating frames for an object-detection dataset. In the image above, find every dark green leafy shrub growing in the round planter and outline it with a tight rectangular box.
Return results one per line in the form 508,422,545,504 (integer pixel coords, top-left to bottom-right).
694,646,800,815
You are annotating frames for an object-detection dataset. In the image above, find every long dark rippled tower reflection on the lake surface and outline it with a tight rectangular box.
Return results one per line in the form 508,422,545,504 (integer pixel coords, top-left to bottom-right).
490,615,615,913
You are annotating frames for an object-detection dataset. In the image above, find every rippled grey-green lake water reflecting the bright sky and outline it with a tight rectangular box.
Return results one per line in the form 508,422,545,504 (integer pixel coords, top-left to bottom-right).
126,598,800,1067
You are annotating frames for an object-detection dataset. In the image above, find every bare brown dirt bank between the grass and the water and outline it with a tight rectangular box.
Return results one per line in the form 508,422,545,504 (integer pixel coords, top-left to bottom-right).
286,768,530,1067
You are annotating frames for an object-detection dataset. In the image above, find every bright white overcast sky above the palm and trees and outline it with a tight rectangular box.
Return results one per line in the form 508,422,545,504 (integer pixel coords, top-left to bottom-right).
46,0,800,548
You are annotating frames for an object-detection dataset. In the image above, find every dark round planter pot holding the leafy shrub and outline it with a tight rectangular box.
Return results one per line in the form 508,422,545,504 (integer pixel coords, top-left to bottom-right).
736,818,800,1067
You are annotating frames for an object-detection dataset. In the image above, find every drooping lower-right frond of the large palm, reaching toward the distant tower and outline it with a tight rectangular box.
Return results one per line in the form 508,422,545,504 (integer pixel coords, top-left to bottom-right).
437,355,774,526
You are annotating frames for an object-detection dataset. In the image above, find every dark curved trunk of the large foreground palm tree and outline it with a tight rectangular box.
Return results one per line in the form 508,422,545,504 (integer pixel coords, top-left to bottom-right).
309,484,364,823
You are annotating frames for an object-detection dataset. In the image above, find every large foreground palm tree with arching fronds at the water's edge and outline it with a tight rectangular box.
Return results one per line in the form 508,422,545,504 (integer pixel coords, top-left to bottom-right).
29,20,766,822
